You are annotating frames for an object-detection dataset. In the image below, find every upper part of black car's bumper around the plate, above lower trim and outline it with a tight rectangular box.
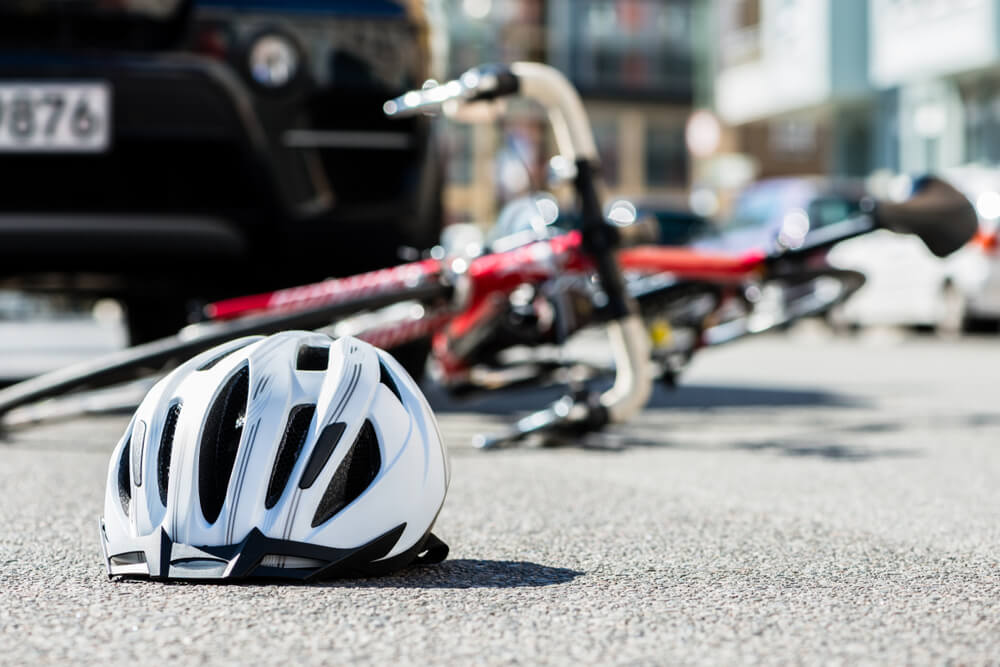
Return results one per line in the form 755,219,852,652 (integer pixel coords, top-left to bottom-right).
0,50,429,223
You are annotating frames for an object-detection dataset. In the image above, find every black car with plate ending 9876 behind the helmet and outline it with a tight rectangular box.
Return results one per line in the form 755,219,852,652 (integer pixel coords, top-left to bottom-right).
0,0,443,342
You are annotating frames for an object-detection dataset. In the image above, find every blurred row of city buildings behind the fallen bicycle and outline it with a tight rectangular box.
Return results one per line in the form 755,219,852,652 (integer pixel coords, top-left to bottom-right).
447,0,1000,217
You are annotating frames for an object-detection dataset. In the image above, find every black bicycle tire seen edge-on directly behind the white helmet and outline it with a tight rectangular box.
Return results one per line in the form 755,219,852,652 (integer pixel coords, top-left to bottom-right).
0,283,450,417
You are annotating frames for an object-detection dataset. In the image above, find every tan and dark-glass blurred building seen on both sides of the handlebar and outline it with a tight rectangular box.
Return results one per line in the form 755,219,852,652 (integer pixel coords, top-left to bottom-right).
447,0,695,221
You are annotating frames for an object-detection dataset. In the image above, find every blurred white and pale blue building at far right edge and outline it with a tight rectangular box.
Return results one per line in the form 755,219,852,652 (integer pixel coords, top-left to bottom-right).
869,0,1000,172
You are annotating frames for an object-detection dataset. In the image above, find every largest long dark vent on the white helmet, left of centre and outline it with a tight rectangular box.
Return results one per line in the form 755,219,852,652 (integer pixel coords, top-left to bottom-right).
198,365,250,523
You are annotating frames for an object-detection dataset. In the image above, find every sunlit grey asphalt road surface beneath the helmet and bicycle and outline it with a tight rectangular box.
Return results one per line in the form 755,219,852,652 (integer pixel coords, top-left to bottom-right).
0,336,1000,664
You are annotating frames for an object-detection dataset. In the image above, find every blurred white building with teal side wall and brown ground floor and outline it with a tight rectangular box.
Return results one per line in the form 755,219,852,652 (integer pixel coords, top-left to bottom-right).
711,0,873,177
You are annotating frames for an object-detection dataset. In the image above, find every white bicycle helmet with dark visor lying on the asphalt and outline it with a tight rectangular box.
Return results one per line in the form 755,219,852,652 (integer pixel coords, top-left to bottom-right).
101,331,449,579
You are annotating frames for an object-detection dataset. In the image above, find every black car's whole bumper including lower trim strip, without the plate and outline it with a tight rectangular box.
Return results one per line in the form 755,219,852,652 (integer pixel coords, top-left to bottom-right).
0,49,439,285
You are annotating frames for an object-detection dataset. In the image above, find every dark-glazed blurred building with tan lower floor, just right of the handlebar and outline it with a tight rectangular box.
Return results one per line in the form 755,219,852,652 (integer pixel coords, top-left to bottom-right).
547,0,694,196
